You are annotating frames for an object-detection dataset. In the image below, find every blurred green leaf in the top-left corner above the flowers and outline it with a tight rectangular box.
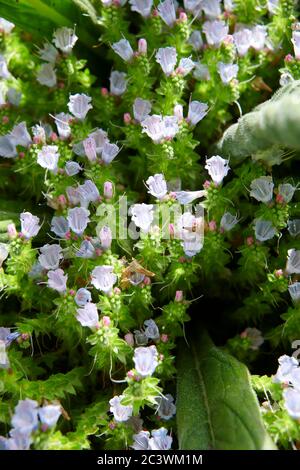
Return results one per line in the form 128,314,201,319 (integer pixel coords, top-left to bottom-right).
0,0,97,48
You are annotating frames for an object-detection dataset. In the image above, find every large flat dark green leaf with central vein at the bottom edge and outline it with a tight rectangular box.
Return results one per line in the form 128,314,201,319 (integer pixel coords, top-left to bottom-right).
177,331,276,450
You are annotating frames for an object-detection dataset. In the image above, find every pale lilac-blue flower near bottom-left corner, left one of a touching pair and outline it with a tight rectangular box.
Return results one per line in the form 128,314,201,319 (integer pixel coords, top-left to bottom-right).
11,398,38,434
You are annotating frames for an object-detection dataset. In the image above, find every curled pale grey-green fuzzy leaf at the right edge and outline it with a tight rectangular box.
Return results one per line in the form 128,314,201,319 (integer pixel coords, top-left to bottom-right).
214,80,300,166
